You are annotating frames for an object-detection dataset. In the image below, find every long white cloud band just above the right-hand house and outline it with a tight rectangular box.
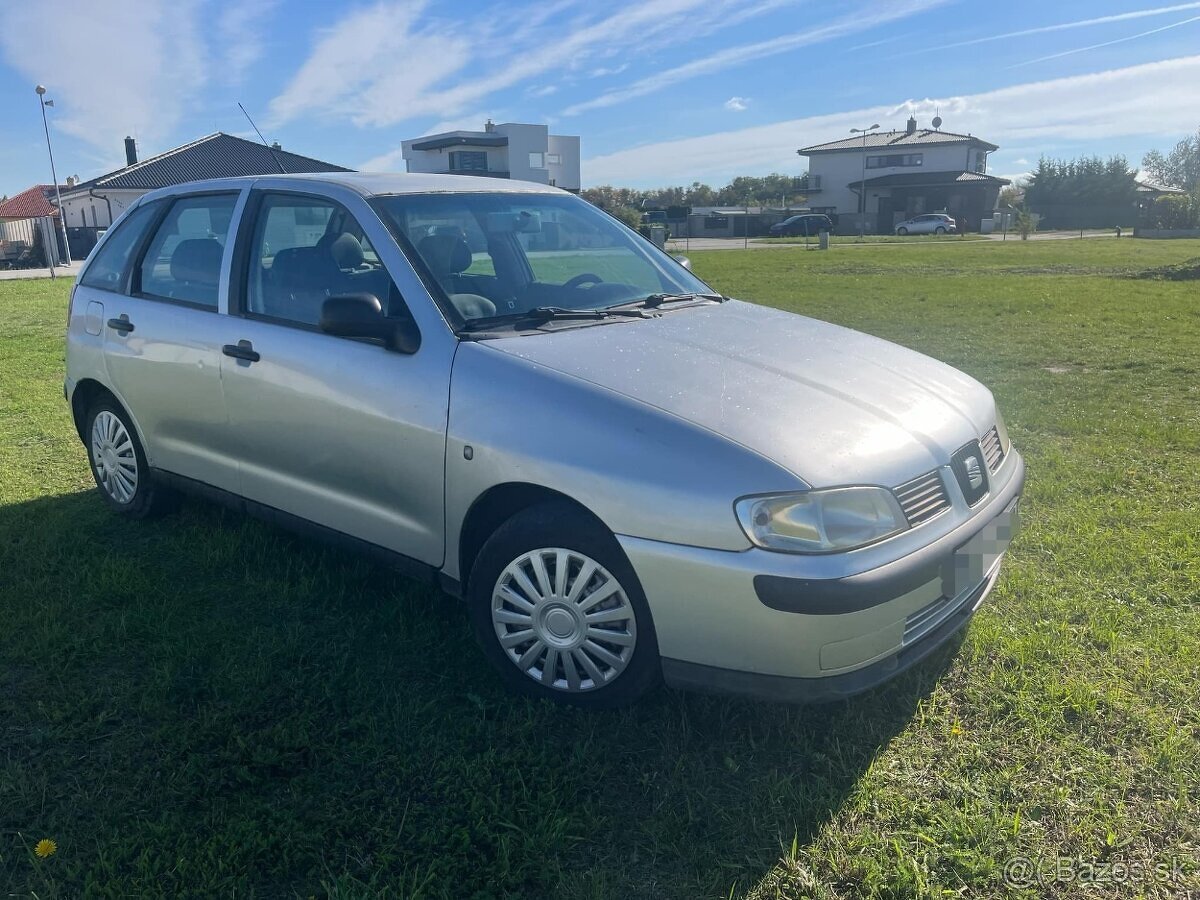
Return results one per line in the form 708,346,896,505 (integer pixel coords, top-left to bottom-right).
583,55,1200,186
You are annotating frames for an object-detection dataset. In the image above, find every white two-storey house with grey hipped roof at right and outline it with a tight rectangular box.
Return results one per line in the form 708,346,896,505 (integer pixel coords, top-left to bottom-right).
797,118,1009,234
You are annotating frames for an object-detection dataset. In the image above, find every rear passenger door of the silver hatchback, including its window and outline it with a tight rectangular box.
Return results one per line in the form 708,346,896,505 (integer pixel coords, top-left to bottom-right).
103,191,240,491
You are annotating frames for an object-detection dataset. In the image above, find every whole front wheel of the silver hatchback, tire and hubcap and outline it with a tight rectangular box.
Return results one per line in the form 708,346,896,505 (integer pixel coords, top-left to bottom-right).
468,503,660,707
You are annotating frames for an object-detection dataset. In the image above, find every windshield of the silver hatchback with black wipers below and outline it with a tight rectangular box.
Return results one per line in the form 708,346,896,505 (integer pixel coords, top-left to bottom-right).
374,192,710,320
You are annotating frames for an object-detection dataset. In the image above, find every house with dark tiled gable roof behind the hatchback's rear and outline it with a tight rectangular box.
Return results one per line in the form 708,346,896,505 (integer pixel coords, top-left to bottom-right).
62,131,350,243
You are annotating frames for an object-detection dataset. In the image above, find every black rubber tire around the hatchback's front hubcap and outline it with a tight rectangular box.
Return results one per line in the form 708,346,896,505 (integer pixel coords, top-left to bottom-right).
467,502,662,709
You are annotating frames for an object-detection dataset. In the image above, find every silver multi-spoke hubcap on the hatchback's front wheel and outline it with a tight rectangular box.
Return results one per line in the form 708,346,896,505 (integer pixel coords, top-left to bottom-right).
492,547,637,692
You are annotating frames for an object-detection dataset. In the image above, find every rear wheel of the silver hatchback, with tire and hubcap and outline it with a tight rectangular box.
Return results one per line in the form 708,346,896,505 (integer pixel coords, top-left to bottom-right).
84,397,173,518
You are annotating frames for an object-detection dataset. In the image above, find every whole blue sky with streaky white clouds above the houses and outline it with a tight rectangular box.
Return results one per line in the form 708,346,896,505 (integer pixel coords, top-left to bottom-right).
0,0,1200,194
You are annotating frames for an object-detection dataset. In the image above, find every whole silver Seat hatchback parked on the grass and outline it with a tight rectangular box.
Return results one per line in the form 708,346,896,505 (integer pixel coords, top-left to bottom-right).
65,174,1025,706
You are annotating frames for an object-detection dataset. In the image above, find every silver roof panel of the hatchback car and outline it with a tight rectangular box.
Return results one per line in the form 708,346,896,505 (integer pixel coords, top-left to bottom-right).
137,172,566,197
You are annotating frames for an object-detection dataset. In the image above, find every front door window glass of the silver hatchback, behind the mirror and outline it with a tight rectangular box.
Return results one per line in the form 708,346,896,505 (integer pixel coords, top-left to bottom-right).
246,193,407,326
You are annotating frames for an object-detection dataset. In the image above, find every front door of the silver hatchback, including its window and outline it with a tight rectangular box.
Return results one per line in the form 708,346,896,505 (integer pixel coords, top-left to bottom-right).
221,191,454,565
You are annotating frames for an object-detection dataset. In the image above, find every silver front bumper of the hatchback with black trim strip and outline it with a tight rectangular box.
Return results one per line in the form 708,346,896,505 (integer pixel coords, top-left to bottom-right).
618,450,1025,701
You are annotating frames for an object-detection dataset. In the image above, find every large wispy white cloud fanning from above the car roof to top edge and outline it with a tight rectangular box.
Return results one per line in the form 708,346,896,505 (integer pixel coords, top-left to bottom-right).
270,0,796,127
